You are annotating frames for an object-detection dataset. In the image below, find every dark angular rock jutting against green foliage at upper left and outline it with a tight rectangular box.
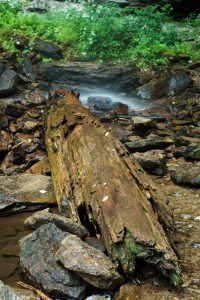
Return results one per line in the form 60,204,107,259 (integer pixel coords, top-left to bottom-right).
32,37,62,59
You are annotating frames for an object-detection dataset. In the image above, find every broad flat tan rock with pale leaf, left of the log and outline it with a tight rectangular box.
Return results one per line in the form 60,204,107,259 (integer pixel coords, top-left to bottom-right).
0,173,56,213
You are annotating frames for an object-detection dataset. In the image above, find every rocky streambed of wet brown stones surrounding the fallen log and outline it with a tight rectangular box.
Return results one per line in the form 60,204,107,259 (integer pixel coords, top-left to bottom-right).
0,46,200,300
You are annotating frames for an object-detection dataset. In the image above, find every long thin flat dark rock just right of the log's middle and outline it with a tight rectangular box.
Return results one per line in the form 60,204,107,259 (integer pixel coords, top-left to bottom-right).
125,135,173,152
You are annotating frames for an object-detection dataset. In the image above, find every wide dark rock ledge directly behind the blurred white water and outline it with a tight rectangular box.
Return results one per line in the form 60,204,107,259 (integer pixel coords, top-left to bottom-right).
37,62,139,91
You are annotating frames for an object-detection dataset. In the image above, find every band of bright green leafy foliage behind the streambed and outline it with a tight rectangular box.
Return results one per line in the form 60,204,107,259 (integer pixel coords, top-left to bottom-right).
0,0,200,67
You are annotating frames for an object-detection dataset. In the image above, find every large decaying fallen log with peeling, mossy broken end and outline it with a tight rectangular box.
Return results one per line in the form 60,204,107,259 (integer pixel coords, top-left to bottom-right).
45,92,180,285
